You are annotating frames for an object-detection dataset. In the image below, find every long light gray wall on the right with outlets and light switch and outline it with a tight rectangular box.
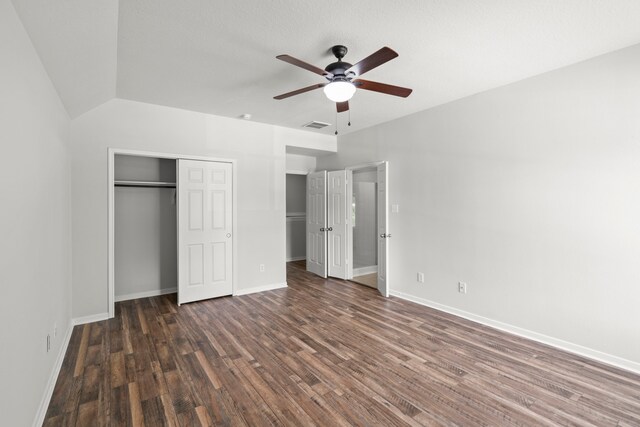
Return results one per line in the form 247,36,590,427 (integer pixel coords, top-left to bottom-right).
317,45,640,371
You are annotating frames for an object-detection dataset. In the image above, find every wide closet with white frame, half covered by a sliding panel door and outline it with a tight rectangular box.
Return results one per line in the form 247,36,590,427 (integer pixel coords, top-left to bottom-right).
107,148,238,318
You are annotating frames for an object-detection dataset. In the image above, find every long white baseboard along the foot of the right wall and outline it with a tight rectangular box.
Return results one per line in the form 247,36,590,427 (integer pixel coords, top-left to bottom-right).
389,291,640,374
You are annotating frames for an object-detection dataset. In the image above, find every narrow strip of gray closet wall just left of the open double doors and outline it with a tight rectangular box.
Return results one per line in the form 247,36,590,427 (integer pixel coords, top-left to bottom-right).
286,174,307,261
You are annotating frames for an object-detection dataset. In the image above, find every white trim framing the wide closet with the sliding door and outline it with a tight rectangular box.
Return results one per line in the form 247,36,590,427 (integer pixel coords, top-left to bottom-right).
107,147,238,318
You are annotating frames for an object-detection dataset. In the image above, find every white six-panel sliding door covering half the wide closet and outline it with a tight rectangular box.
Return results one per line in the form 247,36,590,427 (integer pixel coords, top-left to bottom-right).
177,159,233,304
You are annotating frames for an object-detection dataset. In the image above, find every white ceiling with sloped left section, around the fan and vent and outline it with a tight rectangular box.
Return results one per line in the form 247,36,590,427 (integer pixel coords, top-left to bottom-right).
13,0,640,134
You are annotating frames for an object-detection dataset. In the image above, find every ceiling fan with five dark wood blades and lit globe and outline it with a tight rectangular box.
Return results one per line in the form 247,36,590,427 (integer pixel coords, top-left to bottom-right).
273,45,412,113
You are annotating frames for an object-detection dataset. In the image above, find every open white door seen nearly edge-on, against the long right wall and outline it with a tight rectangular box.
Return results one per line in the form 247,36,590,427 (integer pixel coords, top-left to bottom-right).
378,162,391,297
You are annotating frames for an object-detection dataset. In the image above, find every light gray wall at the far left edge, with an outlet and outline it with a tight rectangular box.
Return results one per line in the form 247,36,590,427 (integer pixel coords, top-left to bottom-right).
0,0,71,426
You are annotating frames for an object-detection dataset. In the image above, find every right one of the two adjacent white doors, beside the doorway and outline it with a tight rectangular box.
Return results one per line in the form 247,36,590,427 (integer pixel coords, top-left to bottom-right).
326,170,348,279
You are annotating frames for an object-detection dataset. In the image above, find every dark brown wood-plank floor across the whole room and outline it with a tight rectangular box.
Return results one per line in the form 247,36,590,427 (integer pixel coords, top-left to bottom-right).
45,263,640,426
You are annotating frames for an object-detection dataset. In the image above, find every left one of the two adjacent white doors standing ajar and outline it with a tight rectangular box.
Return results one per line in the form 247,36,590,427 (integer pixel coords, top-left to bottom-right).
307,171,327,277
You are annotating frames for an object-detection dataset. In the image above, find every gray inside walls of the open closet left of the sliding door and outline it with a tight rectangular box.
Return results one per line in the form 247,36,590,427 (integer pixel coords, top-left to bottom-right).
114,155,178,301
